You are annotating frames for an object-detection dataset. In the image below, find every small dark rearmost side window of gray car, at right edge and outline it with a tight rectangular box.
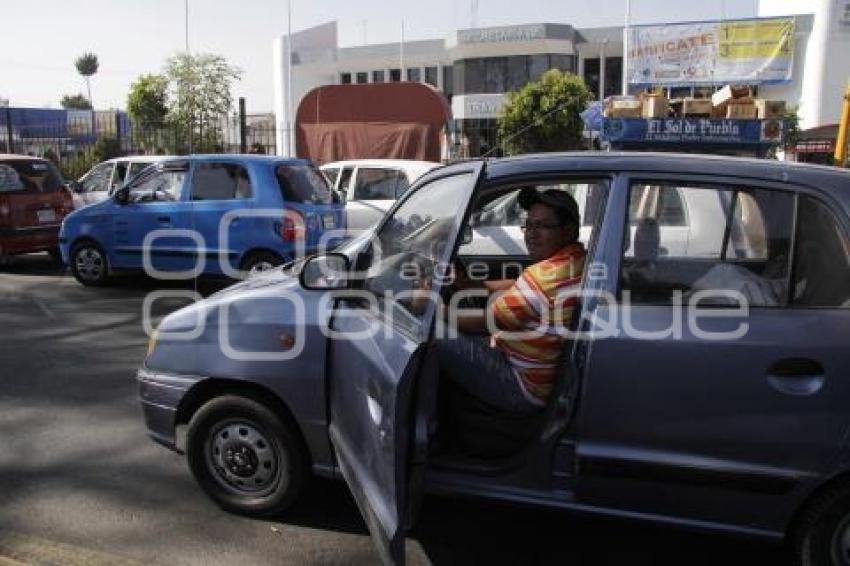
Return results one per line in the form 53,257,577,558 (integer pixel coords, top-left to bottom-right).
792,196,850,308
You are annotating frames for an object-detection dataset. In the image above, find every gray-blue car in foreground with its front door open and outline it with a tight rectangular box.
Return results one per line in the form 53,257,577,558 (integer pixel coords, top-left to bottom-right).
138,153,850,564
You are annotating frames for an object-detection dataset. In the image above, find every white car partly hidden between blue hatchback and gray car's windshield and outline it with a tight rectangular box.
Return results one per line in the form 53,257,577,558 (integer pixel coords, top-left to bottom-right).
320,159,441,235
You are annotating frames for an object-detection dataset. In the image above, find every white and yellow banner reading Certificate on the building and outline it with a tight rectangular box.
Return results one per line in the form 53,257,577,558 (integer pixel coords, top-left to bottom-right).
628,18,794,86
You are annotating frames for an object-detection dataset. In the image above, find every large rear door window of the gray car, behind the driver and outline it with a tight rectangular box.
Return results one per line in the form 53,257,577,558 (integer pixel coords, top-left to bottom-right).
620,183,795,307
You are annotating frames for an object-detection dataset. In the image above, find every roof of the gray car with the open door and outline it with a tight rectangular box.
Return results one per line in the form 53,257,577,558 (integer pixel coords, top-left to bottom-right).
486,151,850,210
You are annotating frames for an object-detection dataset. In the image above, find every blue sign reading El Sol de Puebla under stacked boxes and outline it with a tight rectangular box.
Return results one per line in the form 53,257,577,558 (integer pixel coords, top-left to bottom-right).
600,118,783,145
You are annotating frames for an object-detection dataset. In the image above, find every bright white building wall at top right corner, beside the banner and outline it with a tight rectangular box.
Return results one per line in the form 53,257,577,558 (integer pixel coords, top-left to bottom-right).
759,0,850,129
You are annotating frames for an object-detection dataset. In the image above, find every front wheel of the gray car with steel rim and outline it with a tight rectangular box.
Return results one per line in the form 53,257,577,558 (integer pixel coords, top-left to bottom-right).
186,395,307,517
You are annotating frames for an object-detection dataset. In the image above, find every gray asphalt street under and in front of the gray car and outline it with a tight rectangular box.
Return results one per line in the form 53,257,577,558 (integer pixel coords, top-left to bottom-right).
0,254,792,566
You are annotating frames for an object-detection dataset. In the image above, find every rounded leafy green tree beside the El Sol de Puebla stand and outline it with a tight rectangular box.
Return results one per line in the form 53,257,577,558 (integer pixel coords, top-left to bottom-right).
498,69,592,154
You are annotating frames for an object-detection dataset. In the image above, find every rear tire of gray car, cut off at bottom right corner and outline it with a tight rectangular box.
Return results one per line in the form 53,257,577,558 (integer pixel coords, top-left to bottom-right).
795,484,850,566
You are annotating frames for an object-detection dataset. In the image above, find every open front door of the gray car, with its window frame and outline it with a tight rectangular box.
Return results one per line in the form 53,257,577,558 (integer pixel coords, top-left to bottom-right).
328,162,484,564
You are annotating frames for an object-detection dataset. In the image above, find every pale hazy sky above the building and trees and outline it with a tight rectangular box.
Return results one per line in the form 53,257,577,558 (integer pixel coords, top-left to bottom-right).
0,0,758,112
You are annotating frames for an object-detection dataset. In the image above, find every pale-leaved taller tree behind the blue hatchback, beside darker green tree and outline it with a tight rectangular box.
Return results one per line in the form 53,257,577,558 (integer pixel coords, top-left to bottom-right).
165,53,242,151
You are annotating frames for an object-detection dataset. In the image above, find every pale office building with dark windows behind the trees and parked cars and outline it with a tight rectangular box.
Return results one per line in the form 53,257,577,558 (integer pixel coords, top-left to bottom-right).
274,0,850,157
